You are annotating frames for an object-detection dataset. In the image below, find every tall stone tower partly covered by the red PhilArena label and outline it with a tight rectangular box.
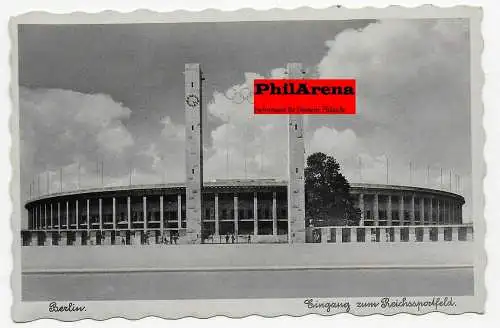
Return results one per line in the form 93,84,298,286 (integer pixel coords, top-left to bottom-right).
286,63,306,243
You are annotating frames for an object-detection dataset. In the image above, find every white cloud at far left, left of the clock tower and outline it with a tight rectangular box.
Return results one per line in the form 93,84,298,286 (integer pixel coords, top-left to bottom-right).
19,87,135,197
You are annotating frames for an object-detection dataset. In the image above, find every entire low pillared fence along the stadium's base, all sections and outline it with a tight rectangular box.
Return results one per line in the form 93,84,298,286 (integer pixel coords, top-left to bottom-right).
21,224,474,246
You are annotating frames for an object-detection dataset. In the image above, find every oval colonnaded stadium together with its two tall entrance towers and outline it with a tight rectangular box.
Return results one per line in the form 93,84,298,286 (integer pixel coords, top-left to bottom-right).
21,63,472,246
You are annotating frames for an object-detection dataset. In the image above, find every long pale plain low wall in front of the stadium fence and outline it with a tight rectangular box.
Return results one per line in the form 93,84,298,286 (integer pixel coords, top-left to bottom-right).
21,242,474,273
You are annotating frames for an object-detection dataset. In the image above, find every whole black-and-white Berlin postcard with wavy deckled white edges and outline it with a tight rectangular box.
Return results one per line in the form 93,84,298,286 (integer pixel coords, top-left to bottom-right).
10,6,486,322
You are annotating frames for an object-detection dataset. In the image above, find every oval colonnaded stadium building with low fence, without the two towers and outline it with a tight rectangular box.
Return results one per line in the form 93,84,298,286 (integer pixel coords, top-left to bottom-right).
23,179,472,245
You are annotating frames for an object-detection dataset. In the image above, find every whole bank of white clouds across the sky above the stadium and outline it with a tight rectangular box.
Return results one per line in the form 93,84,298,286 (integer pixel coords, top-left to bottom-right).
20,19,470,220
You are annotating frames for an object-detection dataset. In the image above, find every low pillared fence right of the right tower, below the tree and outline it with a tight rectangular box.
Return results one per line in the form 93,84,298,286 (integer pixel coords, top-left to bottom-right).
306,224,474,243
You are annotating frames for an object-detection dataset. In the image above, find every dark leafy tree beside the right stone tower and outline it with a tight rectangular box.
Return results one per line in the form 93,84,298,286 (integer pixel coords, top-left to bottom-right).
305,153,361,226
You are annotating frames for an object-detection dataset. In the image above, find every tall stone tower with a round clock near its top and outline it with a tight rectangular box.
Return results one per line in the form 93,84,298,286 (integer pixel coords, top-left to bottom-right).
184,64,203,243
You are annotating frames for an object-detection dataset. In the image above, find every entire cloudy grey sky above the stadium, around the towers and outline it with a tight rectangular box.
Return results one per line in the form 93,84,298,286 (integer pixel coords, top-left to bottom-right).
19,19,471,217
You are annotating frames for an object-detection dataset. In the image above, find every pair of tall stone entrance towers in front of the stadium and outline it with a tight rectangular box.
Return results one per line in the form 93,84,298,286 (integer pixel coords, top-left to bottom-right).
181,63,306,244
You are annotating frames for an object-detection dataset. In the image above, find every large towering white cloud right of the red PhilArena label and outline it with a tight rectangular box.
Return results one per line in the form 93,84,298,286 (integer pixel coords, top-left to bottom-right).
317,19,471,216
